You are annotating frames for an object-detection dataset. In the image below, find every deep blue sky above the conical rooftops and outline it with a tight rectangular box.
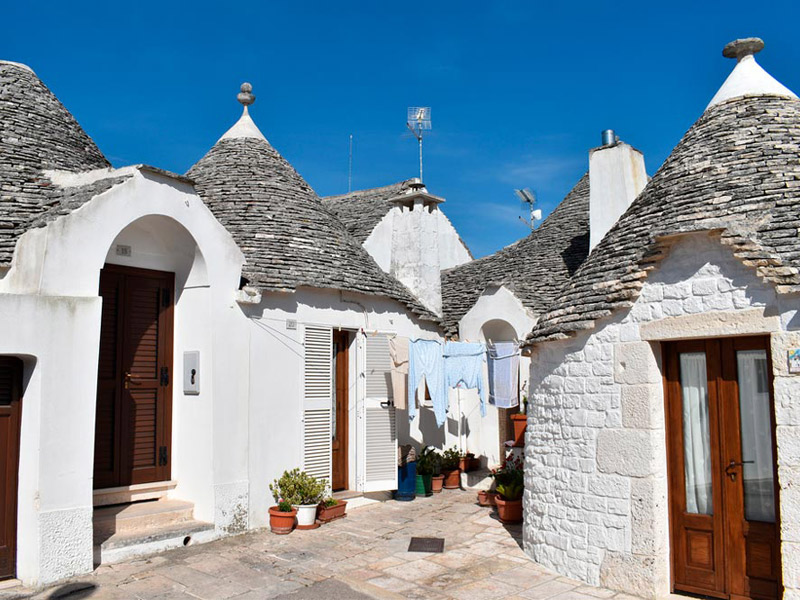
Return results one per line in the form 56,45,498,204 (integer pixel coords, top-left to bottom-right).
6,0,800,256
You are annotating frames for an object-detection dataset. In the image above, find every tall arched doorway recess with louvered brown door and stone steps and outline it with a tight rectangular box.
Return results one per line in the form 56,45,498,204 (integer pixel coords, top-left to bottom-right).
93,215,213,564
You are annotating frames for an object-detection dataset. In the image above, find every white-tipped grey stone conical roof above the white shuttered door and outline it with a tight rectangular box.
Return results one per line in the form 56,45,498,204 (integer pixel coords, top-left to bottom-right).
187,88,438,321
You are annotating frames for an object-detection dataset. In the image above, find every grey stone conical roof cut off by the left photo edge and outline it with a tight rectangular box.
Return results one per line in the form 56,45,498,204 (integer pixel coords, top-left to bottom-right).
0,61,112,266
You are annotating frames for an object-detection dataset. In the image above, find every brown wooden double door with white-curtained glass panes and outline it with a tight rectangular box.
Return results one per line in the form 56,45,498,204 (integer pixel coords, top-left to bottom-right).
664,337,782,599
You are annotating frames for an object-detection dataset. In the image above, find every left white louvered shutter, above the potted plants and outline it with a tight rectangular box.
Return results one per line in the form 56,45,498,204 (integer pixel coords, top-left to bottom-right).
303,327,333,481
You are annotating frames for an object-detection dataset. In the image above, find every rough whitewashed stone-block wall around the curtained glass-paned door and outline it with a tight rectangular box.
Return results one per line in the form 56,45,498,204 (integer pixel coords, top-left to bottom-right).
524,234,800,597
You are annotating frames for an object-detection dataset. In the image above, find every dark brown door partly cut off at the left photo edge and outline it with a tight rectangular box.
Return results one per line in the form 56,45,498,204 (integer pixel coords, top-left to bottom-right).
0,356,22,579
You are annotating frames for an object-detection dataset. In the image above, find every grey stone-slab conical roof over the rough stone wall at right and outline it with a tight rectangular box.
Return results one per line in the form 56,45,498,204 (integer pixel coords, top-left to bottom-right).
528,94,800,343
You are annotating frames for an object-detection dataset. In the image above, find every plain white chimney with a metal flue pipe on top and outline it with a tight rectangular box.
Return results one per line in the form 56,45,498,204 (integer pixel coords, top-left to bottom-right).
589,129,647,251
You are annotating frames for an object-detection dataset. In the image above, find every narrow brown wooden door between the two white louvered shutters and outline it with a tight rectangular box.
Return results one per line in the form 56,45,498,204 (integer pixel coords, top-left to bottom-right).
331,331,350,490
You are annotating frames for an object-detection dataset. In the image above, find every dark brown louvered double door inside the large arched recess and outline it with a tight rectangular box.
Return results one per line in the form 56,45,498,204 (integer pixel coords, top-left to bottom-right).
94,265,174,489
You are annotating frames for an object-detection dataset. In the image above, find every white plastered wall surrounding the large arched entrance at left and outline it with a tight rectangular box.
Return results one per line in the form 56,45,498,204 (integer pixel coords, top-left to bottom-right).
0,169,247,584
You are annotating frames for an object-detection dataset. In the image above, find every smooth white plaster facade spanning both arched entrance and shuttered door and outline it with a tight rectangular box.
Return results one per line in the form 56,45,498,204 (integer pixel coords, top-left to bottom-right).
0,167,450,585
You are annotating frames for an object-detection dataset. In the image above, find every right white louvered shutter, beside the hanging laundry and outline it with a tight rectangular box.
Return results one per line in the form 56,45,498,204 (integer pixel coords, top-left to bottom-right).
363,334,397,492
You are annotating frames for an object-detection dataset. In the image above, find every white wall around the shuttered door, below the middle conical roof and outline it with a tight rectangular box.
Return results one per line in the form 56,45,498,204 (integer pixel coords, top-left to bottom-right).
242,288,438,527
